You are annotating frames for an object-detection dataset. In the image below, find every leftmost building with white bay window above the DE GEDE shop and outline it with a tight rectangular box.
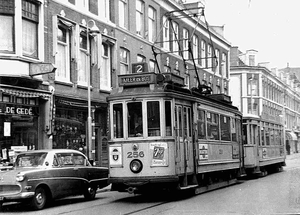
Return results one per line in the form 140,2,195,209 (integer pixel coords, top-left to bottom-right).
0,0,53,161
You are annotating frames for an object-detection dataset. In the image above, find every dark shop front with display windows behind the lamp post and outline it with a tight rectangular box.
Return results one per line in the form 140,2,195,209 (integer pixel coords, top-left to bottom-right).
52,96,108,166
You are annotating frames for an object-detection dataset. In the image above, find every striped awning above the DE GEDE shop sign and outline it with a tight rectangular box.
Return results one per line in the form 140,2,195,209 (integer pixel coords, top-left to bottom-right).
0,88,51,100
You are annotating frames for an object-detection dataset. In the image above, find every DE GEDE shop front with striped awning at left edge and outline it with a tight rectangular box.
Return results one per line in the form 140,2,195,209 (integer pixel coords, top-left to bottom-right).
0,85,51,162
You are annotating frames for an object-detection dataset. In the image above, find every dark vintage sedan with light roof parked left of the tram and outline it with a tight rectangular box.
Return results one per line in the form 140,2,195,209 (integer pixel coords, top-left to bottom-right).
0,149,108,210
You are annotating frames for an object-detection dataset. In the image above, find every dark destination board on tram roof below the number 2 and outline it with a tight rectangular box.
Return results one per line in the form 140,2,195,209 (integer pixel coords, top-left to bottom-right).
118,73,156,86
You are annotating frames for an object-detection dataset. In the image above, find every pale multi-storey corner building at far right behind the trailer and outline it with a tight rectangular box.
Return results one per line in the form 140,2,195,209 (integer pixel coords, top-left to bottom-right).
230,47,300,154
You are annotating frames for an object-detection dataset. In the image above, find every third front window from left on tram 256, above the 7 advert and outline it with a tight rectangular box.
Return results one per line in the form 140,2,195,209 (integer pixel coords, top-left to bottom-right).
147,101,160,137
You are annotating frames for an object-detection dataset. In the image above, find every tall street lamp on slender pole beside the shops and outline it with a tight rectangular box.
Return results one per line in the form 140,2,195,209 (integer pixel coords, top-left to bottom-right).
86,20,100,159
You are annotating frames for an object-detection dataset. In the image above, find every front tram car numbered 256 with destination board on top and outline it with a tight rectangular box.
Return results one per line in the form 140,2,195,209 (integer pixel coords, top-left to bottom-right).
108,73,248,193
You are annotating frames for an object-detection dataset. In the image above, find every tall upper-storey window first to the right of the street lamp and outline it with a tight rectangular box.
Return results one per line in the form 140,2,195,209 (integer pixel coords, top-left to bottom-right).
100,43,111,90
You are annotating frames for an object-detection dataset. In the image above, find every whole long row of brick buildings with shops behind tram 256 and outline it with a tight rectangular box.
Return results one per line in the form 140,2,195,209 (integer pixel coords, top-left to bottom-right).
0,0,230,166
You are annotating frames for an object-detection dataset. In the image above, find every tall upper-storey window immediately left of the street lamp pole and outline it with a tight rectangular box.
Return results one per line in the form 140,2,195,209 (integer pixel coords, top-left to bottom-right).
78,32,89,86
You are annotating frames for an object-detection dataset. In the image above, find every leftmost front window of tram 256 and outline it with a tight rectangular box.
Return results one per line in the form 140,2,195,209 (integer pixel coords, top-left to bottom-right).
113,104,124,138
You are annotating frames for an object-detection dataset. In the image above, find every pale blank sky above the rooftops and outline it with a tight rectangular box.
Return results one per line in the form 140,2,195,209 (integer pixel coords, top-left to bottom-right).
186,0,300,69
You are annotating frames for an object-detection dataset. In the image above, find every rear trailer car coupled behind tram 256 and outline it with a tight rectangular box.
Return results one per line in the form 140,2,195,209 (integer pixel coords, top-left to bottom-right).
243,116,286,177
